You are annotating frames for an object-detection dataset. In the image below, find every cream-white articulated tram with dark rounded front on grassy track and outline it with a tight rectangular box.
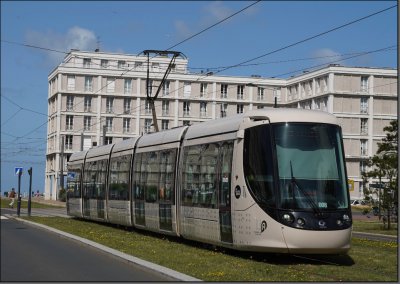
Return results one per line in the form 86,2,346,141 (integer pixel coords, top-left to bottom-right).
67,109,352,254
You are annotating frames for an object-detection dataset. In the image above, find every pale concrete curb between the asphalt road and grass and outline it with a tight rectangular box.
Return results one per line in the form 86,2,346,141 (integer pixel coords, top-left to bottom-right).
9,214,202,282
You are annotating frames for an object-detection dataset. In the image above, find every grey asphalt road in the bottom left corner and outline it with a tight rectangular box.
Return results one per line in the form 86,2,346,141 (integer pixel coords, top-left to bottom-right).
0,219,176,282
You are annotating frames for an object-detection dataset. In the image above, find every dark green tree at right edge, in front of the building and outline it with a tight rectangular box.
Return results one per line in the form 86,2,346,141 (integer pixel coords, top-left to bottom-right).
363,120,398,229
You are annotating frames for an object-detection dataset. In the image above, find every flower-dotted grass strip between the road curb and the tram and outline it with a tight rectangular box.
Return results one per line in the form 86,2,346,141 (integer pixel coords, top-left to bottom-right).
19,217,398,282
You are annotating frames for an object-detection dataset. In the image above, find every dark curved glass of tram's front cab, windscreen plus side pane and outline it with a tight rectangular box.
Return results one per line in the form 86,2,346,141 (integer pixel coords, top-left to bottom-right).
244,123,348,211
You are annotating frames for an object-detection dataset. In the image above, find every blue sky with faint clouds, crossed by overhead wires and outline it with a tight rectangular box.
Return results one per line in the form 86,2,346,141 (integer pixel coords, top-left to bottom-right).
1,1,398,195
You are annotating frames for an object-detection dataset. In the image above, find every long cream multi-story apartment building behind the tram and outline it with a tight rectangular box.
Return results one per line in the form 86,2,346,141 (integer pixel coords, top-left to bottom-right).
45,51,397,199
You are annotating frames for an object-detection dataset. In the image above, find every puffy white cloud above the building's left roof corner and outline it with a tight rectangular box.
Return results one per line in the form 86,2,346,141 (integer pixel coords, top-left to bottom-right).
25,26,97,65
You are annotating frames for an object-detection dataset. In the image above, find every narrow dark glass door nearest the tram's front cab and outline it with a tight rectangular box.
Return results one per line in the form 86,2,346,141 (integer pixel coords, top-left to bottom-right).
218,142,233,243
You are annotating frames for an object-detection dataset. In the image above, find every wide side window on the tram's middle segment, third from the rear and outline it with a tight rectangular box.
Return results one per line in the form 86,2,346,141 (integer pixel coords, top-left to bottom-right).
108,155,132,200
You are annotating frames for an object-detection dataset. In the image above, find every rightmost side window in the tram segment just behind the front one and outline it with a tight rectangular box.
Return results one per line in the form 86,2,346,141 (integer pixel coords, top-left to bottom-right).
158,149,176,201
